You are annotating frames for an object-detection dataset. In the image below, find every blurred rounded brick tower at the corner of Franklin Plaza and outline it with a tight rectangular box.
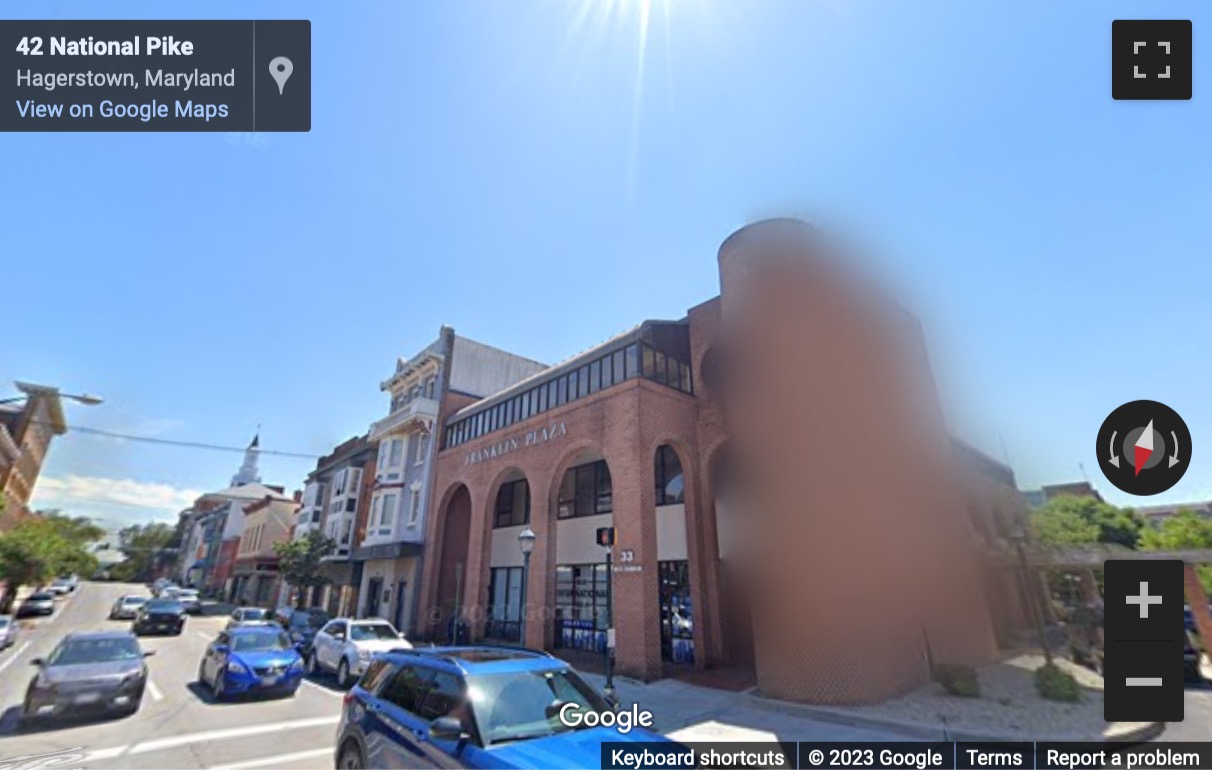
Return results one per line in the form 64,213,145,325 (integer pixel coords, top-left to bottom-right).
719,219,995,703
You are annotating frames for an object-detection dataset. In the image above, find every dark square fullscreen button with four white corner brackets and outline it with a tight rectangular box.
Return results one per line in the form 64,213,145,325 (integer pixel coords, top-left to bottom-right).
1111,19,1191,99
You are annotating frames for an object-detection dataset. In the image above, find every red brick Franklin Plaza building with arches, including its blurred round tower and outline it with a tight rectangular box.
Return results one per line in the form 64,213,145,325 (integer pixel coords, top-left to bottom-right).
422,221,996,703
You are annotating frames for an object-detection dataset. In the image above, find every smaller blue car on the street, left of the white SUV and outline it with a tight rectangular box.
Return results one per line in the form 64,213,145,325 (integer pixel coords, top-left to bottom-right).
198,626,303,701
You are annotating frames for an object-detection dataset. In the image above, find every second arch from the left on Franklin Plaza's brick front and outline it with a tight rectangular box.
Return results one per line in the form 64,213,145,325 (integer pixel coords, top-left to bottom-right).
484,468,531,644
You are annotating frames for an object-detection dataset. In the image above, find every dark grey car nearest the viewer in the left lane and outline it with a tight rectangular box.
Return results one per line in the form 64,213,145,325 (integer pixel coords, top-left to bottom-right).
21,631,152,721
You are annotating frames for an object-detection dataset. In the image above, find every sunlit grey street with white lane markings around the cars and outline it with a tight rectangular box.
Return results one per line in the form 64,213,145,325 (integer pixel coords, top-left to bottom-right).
0,583,1212,770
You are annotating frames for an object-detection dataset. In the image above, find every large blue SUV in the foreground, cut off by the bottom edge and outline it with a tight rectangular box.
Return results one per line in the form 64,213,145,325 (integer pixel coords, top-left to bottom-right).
335,646,676,770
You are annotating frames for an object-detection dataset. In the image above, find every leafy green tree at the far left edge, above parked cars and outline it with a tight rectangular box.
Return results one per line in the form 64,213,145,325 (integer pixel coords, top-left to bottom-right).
0,512,102,612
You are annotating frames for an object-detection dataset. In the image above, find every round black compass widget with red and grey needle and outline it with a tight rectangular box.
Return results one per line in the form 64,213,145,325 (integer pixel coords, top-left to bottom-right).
1097,401,1191,496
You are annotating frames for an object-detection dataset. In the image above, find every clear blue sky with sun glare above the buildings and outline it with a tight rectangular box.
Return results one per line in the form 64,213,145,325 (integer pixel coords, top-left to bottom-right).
7,0,1212,531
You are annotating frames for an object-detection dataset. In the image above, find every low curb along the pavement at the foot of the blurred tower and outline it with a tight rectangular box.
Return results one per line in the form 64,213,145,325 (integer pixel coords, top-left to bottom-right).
744,694,1166,743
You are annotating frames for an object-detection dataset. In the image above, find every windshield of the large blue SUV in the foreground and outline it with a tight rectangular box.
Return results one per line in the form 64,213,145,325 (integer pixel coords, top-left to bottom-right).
468,669,610,745
